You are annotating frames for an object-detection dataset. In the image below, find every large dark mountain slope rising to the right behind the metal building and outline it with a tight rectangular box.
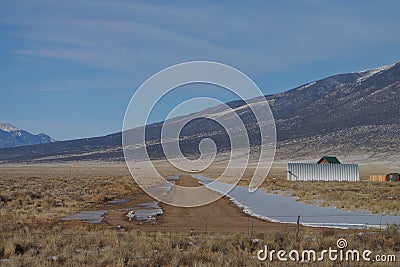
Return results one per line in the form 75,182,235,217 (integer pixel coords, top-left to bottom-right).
0,62,400,162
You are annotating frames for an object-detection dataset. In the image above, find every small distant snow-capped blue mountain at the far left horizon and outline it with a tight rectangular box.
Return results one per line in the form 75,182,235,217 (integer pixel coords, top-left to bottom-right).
0,123,55,148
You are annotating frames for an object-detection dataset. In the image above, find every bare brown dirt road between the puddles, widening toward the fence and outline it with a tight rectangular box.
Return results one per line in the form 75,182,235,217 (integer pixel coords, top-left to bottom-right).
104,175,295,234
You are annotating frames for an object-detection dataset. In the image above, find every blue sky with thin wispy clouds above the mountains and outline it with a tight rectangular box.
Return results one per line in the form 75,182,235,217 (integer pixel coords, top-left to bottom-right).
0,0,400,140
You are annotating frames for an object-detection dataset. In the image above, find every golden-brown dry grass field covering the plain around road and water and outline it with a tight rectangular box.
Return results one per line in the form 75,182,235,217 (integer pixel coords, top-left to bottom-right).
0,163,400,266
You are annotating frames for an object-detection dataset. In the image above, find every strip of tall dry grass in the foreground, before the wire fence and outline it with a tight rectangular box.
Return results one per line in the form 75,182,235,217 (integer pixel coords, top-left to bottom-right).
0,224,400,266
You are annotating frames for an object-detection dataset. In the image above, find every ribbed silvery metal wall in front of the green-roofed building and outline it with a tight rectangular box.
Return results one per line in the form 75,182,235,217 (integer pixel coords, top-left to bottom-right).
287,162,360,182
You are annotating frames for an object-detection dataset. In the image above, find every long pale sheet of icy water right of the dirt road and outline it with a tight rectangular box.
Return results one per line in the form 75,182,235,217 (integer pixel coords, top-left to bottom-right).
193,175,400,228
